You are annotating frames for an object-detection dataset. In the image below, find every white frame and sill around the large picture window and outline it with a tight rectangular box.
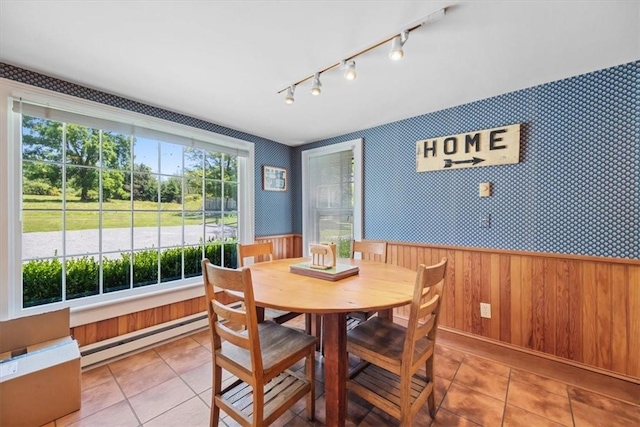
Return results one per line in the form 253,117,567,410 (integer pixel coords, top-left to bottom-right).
0,78,255,327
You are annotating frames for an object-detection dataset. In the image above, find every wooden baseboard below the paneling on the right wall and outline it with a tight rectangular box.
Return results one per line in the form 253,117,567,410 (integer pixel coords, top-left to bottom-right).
438,327,640,405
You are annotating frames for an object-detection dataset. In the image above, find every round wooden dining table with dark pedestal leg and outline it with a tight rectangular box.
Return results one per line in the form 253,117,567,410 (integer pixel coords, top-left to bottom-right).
249,258,416,426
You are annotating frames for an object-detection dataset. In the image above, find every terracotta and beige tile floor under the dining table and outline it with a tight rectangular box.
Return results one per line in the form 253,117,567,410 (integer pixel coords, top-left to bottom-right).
48,320,640,427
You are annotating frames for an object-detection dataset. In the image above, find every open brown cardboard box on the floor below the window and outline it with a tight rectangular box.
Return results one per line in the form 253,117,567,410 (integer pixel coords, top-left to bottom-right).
0,308,81,427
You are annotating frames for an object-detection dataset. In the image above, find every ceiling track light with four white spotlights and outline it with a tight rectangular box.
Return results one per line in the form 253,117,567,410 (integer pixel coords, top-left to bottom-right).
278,8,446,104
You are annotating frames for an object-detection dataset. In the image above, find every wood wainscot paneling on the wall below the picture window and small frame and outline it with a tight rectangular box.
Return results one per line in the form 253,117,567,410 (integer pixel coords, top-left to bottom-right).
71,234,302,347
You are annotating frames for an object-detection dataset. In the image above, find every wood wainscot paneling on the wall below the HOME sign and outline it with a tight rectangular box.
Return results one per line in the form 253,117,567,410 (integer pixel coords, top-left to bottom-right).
387,242,640,378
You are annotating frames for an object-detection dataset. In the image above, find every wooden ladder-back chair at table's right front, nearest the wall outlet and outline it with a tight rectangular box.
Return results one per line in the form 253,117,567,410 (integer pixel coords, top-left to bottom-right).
347,258,447,426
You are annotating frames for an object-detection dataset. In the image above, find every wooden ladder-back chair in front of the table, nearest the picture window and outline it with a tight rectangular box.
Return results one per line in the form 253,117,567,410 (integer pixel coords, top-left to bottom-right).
202,259,316,426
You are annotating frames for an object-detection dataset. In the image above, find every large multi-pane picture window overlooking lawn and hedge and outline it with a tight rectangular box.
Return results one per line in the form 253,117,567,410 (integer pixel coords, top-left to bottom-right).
0,83,252,318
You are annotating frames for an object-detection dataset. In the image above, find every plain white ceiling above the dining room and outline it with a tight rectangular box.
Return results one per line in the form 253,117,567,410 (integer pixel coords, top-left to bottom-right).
0,0,640,146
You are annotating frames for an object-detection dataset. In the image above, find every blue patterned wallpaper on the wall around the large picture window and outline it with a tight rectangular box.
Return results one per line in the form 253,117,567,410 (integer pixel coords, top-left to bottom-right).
0,62,293,236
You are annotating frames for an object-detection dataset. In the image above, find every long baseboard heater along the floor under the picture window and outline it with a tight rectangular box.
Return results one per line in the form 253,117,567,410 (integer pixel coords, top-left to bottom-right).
80,312,209,368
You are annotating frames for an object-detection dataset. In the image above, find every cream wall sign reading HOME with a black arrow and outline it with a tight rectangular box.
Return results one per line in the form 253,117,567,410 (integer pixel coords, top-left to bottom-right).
416,123,520,172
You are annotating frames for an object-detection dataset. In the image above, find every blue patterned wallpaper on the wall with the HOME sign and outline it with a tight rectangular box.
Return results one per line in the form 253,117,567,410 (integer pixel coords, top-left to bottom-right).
293,61,640,259
